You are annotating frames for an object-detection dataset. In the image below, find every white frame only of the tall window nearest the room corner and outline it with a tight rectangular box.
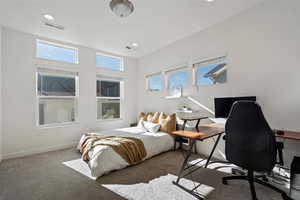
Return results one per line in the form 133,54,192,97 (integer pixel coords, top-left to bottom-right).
96,76,125,122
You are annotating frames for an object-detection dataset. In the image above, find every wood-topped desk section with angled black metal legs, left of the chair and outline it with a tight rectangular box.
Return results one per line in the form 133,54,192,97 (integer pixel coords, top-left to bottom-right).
171,123,225,199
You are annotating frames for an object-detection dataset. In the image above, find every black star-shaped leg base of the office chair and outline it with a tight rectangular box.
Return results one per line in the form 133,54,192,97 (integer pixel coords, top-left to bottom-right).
222,171,293,200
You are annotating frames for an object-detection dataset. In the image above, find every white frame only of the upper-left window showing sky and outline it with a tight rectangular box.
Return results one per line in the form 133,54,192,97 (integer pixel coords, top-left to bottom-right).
35,39,79,65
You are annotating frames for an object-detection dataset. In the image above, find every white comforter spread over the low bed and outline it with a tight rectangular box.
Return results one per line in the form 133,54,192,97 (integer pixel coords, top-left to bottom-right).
77,127,174,177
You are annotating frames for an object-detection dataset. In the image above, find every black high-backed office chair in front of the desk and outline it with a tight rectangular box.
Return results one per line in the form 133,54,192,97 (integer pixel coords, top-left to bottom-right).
223,101,291,200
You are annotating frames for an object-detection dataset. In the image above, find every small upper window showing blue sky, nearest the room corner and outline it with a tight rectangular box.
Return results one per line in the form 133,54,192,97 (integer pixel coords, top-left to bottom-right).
96,54,123,71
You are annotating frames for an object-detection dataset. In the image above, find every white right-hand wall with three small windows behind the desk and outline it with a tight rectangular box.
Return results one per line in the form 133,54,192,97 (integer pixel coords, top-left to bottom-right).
138,0,300,166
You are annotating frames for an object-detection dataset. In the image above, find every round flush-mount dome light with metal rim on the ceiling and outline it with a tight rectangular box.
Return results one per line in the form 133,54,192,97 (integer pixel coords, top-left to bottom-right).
109,0,134,17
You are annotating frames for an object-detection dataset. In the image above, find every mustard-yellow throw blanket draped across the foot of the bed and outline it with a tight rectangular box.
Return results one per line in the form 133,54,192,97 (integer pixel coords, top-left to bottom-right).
79,134,147,165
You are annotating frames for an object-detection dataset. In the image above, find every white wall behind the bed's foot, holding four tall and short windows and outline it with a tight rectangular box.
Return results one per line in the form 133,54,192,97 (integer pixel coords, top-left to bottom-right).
2,28,137,158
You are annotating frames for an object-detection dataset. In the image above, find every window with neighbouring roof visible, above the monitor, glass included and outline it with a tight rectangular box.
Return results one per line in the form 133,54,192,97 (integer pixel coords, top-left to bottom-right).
194,57,227,86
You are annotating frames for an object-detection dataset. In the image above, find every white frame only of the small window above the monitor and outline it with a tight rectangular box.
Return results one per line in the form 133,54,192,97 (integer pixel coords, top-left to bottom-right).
192,55,227,88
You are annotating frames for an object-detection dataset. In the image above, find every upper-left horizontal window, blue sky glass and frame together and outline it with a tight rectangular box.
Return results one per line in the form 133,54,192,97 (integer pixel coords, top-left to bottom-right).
36,40,78,64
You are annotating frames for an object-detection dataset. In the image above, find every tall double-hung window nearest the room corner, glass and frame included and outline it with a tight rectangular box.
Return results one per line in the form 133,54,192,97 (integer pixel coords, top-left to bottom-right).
96,78,122,120
